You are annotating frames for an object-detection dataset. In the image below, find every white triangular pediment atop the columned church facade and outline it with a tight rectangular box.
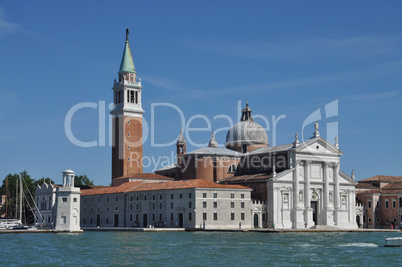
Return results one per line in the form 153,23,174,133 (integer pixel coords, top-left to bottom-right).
295,137,343,155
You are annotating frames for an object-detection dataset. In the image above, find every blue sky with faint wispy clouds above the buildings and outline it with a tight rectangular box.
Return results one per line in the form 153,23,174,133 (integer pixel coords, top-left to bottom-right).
0,1,402,185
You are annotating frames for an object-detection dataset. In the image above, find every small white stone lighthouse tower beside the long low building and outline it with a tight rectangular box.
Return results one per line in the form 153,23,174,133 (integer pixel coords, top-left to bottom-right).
55,169,82,232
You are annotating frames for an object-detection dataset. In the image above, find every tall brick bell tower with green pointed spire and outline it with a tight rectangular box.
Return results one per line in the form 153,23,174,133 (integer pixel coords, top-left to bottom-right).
110,29,144,180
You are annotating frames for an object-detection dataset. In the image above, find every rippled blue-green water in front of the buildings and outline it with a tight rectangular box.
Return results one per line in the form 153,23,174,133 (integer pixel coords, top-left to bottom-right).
0,232,402,266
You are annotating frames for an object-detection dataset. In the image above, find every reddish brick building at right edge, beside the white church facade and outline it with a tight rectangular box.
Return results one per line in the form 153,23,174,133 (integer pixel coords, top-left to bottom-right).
356,175,402,228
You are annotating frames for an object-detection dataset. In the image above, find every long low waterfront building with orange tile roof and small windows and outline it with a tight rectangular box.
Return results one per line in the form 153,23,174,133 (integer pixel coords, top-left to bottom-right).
81,179,253,229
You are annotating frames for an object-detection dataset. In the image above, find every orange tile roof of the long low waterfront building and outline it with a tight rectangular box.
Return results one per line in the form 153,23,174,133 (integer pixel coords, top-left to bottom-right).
81,179,250,196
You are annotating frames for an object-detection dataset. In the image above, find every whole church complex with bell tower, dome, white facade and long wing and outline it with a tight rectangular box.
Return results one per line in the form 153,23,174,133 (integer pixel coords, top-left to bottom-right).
80,31,357,229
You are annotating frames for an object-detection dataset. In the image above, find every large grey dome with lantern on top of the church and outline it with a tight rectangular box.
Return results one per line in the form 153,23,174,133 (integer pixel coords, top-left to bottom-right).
225,102,269,147
